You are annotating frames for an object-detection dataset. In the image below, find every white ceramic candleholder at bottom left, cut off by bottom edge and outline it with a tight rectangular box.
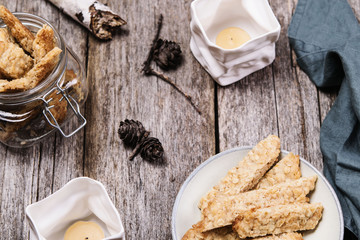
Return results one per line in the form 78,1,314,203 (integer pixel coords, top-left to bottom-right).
26,177,125,240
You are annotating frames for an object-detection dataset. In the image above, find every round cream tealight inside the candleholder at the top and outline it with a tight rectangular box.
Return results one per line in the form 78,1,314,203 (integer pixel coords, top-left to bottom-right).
216,27,250,49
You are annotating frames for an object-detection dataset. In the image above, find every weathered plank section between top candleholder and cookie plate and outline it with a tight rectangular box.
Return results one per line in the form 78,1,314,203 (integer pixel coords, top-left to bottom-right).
218,66,278,151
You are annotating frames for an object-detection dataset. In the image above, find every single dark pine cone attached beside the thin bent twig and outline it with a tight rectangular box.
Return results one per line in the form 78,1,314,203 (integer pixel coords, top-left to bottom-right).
154,39,182,70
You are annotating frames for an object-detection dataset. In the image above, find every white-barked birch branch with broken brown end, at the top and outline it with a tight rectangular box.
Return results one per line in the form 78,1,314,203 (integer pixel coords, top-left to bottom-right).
49,0,126,40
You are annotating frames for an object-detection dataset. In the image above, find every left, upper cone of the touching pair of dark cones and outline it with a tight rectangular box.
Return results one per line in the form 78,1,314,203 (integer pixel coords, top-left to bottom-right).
118,119,149,148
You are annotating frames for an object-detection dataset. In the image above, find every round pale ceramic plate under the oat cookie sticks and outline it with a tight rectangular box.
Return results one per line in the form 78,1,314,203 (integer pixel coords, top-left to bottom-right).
171,147,344,240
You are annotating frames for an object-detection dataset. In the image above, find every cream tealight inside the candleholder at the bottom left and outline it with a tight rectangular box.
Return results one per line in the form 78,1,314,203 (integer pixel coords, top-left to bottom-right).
64,221,105,240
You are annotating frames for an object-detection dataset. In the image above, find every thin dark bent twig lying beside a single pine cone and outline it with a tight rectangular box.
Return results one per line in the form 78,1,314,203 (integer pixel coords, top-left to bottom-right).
142,14,201,114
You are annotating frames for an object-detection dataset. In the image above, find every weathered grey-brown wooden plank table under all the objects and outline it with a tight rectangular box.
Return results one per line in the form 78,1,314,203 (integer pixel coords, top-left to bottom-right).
0,0,360,239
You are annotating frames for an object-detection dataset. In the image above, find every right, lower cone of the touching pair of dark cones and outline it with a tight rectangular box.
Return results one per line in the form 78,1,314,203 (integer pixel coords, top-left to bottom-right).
140,137,164,161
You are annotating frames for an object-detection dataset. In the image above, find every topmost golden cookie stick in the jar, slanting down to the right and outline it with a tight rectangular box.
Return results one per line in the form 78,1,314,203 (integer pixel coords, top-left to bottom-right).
0,5,35,53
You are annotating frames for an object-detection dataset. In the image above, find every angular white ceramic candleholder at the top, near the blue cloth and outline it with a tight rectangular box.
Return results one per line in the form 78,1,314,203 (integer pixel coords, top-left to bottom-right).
190,0,280,86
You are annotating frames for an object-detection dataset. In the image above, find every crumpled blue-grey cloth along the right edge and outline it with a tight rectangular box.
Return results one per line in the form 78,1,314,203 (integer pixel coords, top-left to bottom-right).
288,0,360,239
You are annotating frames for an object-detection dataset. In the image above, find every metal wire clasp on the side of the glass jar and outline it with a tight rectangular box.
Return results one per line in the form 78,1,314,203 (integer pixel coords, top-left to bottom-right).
40,82,86,138
